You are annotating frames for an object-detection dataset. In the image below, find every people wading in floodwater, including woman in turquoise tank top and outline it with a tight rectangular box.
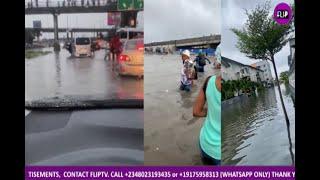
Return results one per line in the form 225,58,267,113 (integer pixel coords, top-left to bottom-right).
180,49,222,165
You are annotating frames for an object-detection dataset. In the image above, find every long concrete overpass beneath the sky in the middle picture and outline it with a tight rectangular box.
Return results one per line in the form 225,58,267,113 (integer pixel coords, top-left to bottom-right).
145,35,221,49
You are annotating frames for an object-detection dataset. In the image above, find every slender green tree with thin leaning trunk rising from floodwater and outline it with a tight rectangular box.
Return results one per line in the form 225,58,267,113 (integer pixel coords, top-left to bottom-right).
231,1,294,163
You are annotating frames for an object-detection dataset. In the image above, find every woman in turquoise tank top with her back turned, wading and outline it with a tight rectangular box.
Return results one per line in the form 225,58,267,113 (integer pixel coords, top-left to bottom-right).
193,59,221,165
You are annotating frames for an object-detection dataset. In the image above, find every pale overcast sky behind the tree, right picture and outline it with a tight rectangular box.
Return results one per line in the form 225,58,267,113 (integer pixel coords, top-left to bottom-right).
220,0,294,77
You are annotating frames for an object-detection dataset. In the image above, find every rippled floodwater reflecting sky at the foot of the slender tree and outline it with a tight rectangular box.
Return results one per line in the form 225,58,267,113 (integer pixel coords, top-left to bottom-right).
222,85,295,165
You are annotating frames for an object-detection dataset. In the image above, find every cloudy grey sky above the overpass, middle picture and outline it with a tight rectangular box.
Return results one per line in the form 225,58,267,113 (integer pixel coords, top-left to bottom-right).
144,0,221,43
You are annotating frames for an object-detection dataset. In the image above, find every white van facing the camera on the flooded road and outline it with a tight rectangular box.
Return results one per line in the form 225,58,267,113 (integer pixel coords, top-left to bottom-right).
73,37,92,57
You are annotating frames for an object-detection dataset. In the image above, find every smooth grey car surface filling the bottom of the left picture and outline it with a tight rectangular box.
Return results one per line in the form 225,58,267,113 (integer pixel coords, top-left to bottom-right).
25,109,144,166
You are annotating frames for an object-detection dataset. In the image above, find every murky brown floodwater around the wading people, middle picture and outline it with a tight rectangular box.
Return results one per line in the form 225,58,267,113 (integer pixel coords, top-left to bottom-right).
144,54,218,165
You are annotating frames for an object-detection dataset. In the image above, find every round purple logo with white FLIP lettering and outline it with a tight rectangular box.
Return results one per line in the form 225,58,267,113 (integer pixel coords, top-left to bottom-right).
273,3,292,25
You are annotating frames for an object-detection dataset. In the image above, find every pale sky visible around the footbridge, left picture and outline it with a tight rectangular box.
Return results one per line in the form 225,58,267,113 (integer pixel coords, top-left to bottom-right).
25,0,144,38
